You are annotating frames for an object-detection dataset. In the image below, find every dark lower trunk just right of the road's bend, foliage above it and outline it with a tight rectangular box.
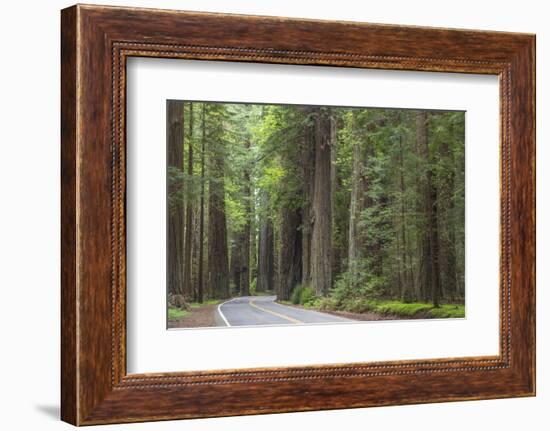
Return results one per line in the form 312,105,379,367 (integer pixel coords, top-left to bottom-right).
277,208,302,300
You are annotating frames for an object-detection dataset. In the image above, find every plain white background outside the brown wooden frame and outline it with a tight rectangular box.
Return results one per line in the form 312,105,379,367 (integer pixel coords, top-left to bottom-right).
0,0,550,431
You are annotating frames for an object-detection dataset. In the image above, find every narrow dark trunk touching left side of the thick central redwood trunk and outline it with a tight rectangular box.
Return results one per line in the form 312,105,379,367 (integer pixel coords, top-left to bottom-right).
301,107,315,286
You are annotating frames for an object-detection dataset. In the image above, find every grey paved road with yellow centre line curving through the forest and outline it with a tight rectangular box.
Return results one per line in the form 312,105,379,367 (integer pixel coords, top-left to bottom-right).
218,296,352,326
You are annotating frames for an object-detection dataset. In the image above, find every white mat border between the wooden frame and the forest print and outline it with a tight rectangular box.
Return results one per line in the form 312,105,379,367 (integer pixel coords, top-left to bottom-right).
127,58,500,373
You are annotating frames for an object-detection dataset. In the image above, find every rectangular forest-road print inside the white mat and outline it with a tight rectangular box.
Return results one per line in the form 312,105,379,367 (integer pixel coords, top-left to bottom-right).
166,100,465,328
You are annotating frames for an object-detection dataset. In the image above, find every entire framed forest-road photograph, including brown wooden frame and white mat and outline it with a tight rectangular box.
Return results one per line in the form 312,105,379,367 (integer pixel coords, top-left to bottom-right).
61,5,535,425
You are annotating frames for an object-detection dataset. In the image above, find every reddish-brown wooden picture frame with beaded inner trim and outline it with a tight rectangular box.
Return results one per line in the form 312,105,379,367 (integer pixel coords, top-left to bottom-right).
61,5,535,425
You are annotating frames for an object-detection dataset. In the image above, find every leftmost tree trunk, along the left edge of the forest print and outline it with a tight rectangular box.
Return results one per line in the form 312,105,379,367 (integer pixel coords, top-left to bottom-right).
167,100,185,294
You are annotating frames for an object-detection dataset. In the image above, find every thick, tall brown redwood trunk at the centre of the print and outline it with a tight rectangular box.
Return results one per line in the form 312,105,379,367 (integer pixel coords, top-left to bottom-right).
311,109,332,296
